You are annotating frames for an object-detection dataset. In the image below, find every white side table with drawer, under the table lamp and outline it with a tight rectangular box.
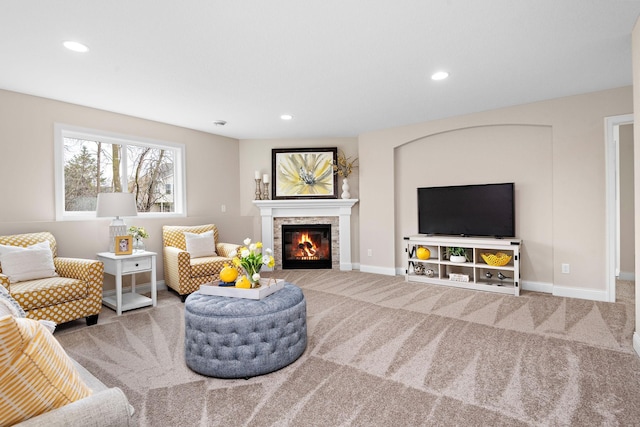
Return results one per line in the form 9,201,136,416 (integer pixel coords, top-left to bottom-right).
96,251,157,316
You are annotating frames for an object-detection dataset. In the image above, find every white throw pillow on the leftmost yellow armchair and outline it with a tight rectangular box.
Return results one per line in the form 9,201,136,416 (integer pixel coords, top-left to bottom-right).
0,241,57,283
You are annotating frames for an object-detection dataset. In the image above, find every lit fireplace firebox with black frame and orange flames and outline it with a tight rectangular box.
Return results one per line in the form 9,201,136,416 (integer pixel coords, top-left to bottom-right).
282,224,331,270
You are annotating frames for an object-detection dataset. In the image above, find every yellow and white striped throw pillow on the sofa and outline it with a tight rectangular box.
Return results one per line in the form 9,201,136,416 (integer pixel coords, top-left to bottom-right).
0,315,91,425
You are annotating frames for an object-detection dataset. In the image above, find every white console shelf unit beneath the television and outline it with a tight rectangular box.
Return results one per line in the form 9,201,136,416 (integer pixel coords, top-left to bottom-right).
404,235,522,296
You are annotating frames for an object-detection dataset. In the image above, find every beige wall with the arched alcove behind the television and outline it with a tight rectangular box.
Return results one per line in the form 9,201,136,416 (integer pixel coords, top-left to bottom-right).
358,87,633,300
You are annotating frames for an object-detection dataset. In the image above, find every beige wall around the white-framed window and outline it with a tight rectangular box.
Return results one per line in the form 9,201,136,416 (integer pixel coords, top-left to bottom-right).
0,90,252,283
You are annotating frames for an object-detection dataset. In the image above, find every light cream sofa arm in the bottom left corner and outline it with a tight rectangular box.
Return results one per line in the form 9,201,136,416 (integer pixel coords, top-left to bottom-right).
15,387,135,427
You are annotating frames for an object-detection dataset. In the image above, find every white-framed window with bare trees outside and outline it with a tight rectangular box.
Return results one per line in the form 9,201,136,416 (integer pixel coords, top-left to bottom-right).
55,124,186,220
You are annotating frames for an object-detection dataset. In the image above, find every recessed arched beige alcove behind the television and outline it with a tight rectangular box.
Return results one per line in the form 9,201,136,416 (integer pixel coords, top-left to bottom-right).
394,124,553,287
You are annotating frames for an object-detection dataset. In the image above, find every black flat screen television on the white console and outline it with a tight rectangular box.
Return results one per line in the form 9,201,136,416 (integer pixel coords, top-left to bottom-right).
418,183,516,237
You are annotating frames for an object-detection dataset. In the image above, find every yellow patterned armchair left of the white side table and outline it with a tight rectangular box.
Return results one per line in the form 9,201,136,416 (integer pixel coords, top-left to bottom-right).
0,232,104,325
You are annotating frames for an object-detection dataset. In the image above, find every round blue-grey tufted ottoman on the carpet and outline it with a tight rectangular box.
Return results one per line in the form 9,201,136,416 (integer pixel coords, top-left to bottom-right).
184,283,307,378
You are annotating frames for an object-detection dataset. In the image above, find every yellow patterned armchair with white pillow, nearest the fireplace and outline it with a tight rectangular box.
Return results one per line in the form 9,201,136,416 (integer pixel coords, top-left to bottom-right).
162,224,240,302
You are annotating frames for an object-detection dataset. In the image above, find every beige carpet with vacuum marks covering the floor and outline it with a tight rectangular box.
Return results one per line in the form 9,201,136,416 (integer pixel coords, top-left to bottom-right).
56,270,640,427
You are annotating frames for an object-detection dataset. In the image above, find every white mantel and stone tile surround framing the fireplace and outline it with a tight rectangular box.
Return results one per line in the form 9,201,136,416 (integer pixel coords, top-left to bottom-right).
253,199,358,270
